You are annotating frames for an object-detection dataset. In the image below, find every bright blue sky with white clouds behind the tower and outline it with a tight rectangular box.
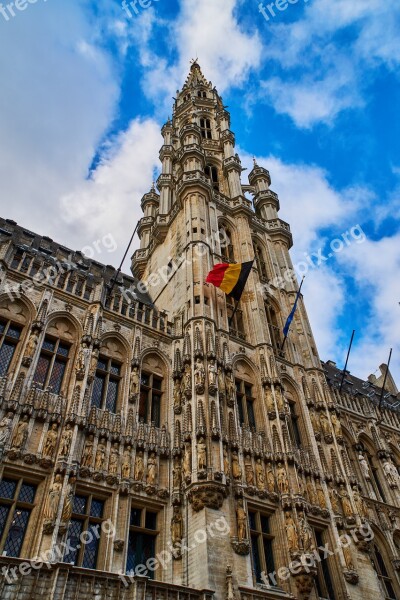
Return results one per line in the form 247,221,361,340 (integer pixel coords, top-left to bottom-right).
0,0,400,387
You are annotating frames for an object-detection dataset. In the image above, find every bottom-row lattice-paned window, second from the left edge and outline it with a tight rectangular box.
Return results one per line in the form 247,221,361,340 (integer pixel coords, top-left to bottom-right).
64,494,104,569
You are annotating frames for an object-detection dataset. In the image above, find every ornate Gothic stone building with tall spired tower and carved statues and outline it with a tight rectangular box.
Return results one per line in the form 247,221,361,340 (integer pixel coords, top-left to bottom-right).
0,63,400,600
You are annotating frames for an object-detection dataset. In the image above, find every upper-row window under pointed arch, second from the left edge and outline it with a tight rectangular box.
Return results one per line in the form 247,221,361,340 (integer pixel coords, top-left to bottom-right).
33,336,71,394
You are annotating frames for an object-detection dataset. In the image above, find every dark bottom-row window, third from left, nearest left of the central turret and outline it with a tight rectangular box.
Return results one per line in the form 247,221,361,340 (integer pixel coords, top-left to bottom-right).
126,506,158,579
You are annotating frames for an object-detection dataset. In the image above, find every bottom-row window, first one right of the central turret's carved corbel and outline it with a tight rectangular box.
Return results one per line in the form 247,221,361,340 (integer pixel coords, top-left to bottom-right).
249,510,276,585
